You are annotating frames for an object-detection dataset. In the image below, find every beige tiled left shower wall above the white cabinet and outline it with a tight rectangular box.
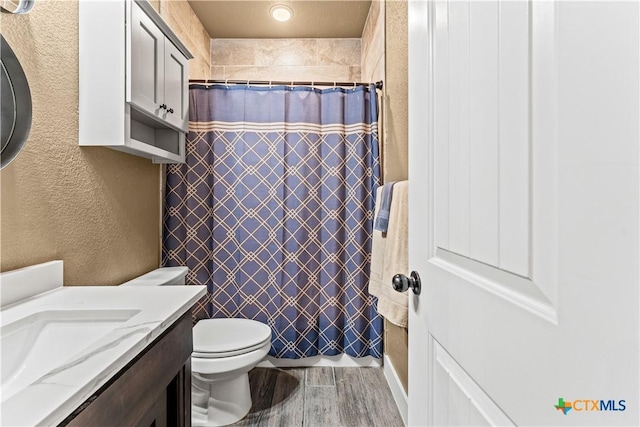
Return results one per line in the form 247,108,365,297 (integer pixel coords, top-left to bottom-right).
151,0,211,79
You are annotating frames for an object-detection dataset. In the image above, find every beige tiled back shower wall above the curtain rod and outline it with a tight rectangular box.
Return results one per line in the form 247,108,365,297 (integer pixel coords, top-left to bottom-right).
211,39,361,82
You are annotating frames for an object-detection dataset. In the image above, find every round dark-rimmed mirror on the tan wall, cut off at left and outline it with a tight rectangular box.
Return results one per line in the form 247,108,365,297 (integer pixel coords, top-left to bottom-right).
0,34,31,169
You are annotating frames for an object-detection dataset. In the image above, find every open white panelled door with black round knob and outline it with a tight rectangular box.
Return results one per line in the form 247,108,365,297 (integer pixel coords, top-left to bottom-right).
408,0,640,425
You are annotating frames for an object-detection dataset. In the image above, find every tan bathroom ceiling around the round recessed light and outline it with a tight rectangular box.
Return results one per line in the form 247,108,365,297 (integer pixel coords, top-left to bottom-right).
189,0,371,38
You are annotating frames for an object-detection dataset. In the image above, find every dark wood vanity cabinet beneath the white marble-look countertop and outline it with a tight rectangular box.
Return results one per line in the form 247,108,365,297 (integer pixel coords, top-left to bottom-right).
61,312,193,427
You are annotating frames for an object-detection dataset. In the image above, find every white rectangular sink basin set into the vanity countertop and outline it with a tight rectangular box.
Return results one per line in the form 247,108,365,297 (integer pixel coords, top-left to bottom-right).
0,309,140,401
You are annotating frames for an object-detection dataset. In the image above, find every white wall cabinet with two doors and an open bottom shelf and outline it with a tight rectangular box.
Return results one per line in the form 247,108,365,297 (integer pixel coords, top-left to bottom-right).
79,0,193,163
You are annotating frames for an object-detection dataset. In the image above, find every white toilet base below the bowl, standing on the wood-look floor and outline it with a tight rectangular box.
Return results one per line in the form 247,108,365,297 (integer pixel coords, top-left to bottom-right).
191,372,251,427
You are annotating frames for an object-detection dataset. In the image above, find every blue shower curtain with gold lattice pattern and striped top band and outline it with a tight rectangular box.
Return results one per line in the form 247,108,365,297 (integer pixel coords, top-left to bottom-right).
163,85,382,358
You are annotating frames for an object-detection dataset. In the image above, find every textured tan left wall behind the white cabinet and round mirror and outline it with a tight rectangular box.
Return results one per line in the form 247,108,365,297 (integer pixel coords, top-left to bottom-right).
0,0,209,285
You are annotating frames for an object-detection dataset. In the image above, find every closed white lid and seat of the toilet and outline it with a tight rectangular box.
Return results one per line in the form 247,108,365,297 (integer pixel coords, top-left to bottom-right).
193,319,271,358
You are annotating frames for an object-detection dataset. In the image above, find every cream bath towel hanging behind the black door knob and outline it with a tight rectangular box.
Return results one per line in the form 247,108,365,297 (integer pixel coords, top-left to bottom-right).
369,181,409,328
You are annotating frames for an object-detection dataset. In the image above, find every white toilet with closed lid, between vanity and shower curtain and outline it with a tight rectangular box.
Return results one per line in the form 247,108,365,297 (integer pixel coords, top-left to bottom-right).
122,267,271,426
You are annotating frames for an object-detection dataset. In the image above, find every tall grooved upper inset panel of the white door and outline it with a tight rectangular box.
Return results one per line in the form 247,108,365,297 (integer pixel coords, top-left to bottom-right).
433,1,531,277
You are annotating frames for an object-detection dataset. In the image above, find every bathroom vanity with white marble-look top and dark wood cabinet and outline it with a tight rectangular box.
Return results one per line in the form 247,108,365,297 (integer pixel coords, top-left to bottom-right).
0,261,206,426
